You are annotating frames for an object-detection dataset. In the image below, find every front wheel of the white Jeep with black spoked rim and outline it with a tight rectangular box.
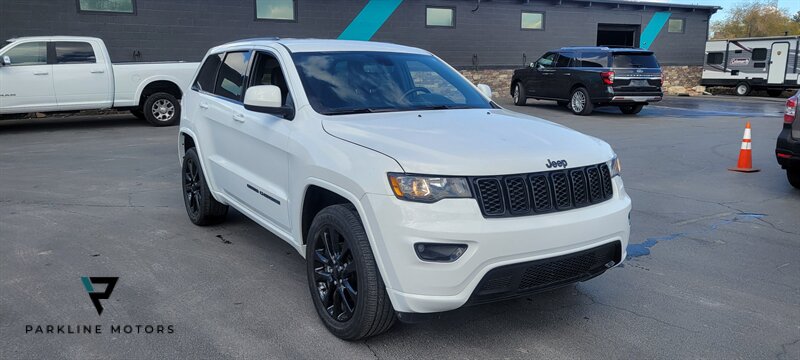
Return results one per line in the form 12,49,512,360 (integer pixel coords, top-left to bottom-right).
306,204,396,340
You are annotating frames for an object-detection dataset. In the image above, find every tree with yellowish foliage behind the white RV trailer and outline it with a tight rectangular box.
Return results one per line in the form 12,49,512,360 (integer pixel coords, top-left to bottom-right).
711,0,800,39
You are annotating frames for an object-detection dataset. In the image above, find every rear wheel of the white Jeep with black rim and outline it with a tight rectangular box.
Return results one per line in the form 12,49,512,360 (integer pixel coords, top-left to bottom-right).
181,148,228,226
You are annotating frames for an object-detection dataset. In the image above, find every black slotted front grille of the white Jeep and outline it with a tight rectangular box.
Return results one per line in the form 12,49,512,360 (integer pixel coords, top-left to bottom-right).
470,164,614,217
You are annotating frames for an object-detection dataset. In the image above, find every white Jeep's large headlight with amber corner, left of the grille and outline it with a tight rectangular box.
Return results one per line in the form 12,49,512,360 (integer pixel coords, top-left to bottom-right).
389,173,472,203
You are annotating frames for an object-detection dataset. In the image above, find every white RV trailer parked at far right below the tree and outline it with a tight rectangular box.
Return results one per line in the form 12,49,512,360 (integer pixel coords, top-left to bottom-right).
700,36,800,96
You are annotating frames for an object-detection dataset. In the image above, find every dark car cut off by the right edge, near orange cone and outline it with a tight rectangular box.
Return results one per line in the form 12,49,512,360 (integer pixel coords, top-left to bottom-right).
775,90,800,189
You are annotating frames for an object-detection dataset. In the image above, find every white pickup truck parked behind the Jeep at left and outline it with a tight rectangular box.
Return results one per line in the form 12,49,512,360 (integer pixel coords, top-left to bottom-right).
0,36,198,126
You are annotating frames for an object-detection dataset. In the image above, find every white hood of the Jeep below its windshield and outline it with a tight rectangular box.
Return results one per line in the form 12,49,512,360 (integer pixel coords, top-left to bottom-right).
322,109,613,176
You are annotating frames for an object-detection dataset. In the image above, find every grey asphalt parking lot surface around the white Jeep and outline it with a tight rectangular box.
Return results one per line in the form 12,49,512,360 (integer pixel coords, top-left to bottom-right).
0,97,800,359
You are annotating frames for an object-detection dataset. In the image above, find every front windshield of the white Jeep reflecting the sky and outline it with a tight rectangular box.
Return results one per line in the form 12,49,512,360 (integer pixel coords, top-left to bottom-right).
293,52,491,115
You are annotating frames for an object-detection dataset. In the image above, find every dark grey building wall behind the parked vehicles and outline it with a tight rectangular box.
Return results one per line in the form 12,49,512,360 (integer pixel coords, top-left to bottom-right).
0,0,710,67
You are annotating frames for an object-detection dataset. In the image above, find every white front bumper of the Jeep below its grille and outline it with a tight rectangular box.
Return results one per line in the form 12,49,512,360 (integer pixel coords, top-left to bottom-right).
362,177,631,313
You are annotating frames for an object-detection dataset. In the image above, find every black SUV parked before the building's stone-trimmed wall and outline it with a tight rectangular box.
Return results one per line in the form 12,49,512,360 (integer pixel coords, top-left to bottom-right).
511,47,663,115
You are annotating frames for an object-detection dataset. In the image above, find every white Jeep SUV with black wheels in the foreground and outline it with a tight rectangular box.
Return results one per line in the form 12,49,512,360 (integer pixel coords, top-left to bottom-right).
179,38,631,340
